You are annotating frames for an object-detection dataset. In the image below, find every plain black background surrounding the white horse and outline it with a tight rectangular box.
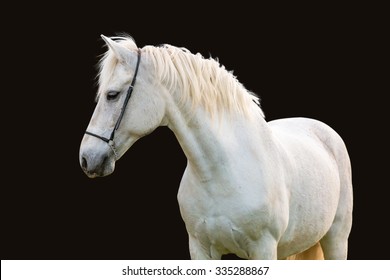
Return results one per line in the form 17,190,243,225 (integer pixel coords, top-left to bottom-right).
0,2,390,259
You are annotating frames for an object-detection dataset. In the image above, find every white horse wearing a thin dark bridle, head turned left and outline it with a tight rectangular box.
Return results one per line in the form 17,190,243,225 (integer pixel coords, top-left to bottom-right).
80,36,352,259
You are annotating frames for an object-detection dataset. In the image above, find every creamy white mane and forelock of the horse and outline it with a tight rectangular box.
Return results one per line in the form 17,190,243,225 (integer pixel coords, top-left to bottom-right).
99,36,264,117
